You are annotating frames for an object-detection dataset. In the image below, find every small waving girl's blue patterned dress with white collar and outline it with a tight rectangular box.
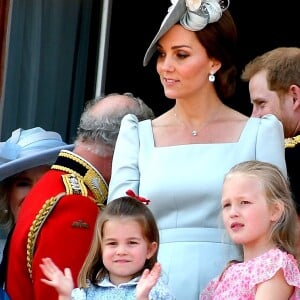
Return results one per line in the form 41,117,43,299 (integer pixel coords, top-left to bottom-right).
72,277,175,300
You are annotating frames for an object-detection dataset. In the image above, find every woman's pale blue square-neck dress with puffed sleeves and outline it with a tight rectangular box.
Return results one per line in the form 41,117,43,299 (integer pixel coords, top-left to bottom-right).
108,115,286,300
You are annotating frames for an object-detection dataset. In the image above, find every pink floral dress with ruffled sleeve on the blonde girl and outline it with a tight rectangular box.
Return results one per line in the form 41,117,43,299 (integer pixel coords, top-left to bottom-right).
199,249,300,300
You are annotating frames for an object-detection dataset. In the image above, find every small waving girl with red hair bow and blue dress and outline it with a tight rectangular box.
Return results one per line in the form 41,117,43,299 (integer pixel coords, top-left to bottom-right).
40,196,175,300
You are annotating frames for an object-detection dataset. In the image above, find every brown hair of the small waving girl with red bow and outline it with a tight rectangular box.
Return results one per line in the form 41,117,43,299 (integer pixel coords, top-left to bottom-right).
78,196,159,288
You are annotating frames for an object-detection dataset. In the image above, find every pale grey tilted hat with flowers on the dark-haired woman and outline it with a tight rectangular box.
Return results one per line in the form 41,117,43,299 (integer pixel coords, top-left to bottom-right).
143,0,230,66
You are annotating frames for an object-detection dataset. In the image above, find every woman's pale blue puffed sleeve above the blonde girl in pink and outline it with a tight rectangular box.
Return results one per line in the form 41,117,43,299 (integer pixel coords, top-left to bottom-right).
256,114,287,176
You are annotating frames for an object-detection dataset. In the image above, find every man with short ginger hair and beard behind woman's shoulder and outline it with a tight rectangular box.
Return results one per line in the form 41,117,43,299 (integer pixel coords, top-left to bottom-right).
241,47,300,213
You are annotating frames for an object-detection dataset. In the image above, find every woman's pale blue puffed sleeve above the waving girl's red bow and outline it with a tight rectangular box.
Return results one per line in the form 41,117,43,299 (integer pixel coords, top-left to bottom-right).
108,114,140,202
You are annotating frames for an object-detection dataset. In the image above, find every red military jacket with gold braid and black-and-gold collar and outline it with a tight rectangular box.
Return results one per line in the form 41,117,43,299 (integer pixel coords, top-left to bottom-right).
6,150,107,300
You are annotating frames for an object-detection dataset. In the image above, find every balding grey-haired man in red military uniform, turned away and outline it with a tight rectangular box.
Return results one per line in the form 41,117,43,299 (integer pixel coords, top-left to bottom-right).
6,94,153,300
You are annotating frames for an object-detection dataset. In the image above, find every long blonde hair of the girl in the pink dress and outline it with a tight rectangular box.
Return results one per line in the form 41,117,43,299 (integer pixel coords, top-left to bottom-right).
224,160,299,262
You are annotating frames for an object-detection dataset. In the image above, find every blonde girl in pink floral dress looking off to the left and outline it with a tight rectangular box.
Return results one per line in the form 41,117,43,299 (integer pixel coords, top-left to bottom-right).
200,161,300,300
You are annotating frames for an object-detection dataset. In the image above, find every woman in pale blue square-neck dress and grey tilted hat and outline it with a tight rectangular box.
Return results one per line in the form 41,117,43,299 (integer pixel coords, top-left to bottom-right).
108,0,286,300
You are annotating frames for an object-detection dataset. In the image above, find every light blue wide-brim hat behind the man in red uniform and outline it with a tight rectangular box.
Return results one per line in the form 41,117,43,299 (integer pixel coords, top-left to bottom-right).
0,127,74,181
